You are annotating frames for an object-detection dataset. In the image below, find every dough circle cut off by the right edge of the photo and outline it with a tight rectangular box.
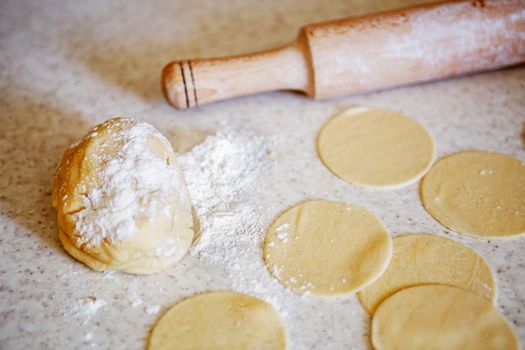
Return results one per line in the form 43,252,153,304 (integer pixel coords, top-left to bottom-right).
421,151,525,238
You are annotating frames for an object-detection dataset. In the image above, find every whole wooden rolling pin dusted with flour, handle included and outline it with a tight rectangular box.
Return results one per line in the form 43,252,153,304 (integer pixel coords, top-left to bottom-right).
162,0,525,109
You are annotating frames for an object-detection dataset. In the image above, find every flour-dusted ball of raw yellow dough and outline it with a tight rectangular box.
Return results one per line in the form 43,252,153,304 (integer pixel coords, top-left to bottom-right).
53,118,193,274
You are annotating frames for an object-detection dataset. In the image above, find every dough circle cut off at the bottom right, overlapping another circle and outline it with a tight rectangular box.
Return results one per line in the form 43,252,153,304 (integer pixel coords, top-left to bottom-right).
372,285,519,350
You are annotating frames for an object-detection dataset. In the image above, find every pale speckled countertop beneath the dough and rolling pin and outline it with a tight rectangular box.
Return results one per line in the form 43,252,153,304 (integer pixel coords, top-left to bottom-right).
0,0,525,349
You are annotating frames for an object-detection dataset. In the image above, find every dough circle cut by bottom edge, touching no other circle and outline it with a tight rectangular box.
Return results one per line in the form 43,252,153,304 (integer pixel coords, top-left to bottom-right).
148,292,286,350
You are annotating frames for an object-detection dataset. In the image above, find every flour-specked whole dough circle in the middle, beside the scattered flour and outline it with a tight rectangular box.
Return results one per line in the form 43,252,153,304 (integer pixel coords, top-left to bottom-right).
263,200,392,295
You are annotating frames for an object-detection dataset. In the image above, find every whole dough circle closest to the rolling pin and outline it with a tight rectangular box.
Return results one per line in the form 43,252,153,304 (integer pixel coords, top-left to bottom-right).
318,107,435,188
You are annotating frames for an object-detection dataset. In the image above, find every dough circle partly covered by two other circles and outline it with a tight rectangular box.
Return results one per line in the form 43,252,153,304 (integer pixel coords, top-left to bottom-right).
359,234,496,313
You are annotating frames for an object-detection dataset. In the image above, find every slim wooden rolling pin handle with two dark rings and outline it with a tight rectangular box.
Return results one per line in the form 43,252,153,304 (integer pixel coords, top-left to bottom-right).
162,40,313,109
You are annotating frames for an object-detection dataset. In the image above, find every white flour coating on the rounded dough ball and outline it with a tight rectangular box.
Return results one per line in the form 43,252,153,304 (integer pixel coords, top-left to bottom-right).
70,119,185,246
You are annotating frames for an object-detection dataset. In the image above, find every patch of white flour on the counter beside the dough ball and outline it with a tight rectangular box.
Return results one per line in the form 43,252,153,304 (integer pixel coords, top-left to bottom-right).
179,132,301,310
